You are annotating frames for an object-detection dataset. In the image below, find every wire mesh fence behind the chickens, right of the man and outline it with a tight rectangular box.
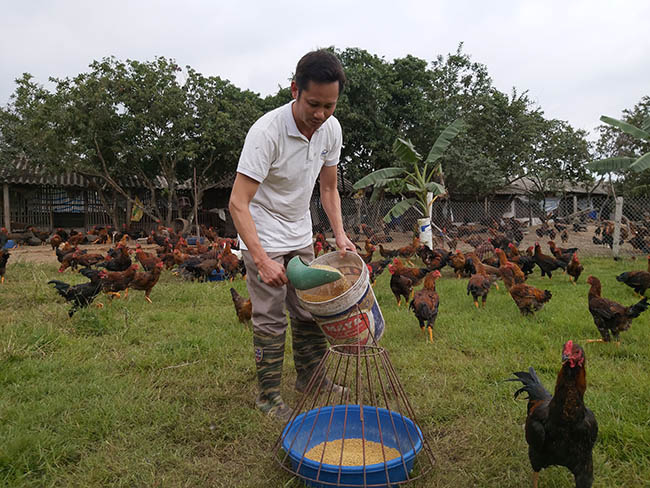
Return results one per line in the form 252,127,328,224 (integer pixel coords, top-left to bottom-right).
311,195,650,256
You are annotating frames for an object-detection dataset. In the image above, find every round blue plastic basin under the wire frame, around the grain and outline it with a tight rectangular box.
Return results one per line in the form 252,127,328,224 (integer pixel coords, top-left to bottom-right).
282,405,422,488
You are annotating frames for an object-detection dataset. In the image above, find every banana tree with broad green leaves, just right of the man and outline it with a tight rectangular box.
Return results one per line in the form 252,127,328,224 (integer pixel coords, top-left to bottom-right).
354,119,465,223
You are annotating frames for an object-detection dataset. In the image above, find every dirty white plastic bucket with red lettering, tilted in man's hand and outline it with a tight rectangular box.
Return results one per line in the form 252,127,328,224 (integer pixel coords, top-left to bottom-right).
296,252,385,345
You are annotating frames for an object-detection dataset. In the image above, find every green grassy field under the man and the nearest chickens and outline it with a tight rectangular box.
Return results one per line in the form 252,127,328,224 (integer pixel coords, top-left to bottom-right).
0,255,650,488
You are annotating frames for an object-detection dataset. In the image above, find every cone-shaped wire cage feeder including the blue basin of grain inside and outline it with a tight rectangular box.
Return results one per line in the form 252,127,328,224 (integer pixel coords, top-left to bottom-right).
273,316,435,488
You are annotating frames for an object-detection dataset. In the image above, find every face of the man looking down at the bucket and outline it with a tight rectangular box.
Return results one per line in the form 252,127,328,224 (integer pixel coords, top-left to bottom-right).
291,81,339,136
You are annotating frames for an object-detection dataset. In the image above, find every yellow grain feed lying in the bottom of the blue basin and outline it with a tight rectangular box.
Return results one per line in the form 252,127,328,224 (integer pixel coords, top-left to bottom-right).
305,439,400,466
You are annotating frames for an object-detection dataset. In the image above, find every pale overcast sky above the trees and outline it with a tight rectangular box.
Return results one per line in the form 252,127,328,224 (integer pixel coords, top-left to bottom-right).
0,0,650,137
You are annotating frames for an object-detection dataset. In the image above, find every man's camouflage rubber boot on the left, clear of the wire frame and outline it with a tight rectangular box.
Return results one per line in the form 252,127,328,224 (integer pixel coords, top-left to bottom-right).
253,332,293,422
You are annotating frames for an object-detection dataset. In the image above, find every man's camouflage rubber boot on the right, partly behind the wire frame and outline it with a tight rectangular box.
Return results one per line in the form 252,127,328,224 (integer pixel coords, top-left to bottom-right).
291,320,343,394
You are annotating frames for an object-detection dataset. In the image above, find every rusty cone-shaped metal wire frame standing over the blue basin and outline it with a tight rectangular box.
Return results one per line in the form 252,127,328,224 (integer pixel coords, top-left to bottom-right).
273,344,435,488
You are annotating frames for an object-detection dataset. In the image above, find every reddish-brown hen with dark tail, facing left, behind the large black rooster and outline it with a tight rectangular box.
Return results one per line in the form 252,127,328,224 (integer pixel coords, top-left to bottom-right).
587,276,648,344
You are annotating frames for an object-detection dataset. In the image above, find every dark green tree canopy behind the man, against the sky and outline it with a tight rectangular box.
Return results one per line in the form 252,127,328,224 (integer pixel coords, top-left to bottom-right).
0,44,604,221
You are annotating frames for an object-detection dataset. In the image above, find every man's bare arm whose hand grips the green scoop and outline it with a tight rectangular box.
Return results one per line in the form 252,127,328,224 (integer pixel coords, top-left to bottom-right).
228,173,288,287
